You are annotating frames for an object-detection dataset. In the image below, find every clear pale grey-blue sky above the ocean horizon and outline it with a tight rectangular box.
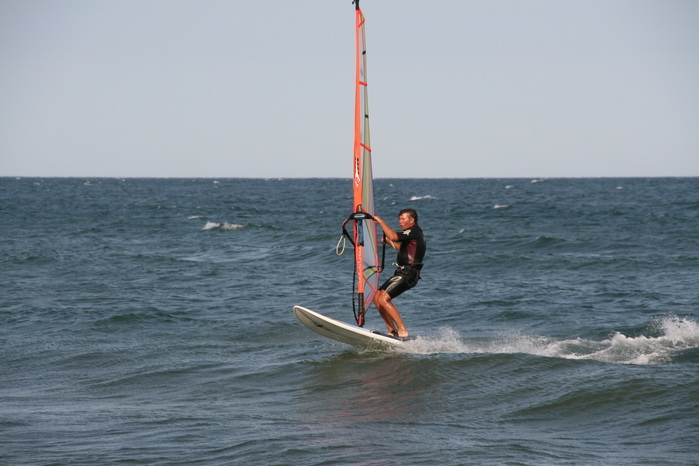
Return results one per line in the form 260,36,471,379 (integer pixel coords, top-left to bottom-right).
0,0,699,178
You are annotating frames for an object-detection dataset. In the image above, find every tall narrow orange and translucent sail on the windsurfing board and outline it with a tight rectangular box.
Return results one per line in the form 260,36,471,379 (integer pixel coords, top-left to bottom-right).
353,0,380,326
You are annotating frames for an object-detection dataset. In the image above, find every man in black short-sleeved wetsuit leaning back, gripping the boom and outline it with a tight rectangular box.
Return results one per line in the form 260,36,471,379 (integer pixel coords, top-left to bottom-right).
374,209,427,338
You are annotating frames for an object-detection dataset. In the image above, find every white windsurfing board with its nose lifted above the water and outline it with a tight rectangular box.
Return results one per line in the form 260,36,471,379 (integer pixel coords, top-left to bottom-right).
294,306,405,347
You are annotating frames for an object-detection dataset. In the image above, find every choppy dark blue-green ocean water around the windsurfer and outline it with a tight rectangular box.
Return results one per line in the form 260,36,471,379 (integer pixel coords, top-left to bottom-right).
0,178,699,466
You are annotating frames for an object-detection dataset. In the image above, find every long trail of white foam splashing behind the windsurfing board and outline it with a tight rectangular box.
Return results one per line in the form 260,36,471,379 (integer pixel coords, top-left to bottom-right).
396,317,699,365
